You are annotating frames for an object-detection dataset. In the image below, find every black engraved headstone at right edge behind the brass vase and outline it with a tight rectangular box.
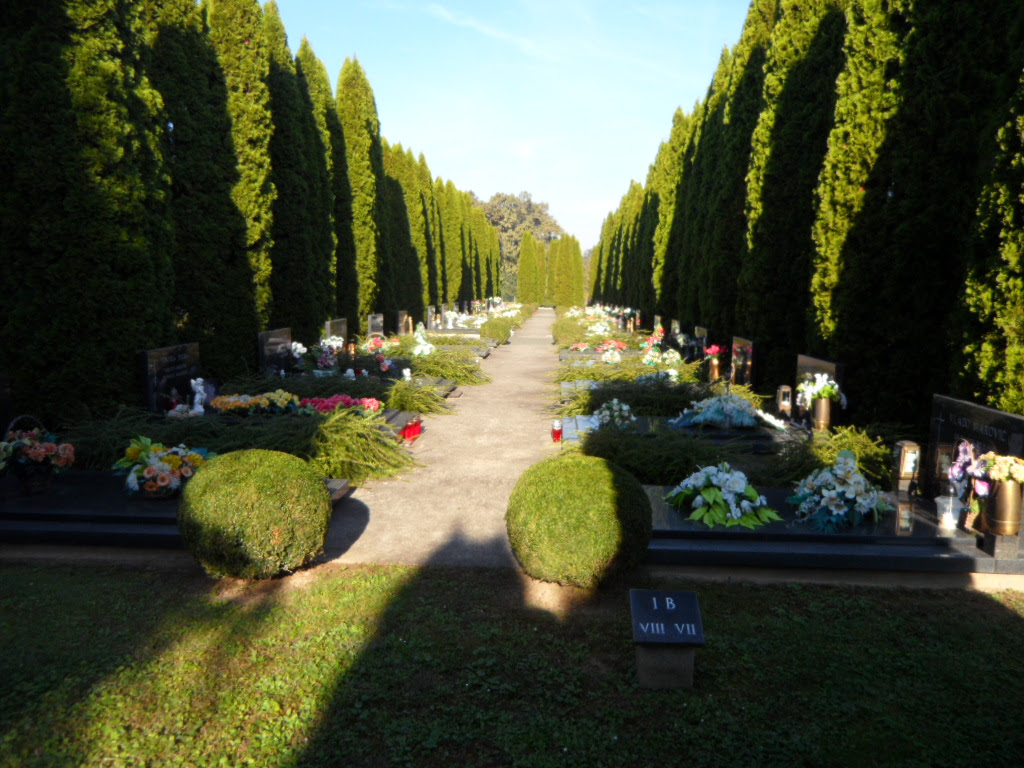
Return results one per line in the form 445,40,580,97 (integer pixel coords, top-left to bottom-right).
921,394,1024,496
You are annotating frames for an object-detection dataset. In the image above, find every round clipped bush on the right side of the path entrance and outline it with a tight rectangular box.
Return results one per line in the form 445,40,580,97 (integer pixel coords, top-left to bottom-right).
505,452,651,588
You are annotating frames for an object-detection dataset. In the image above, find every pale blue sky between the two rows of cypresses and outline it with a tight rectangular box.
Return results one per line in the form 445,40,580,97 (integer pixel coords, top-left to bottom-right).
278,0,749,249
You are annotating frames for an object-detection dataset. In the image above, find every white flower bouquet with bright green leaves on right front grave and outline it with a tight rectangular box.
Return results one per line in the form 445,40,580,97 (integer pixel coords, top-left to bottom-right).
665,462,782,528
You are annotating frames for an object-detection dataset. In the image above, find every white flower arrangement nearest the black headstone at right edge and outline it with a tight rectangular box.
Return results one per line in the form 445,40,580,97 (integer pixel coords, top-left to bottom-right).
786,451,893,534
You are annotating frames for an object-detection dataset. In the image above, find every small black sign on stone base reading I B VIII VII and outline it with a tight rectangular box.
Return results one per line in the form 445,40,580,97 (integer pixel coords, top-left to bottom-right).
630,590,707,688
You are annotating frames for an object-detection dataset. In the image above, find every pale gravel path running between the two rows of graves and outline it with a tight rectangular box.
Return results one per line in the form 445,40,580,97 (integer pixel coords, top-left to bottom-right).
325,309,558,567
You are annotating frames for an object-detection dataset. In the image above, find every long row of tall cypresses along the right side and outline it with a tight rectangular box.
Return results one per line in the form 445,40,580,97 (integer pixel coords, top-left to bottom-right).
589,0,1024,421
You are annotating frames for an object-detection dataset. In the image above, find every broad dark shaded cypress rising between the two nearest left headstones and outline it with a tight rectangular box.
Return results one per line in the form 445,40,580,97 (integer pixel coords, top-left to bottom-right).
145,0,259,379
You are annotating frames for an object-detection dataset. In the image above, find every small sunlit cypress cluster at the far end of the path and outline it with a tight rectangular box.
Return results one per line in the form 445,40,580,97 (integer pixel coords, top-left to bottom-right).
516,229,586,307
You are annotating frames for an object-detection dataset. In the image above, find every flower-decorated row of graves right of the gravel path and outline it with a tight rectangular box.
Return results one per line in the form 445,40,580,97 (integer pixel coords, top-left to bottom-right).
532,306,1024,572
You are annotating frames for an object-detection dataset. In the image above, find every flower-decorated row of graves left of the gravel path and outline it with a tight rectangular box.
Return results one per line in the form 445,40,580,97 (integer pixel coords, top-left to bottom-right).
0,299,531,565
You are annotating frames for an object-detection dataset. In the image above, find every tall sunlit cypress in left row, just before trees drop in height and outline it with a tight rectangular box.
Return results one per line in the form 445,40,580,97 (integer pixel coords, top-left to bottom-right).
335,58,384,324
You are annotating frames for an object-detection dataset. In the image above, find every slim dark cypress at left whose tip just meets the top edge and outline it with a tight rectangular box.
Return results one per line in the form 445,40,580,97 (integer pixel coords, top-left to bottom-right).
263,0,332,344
